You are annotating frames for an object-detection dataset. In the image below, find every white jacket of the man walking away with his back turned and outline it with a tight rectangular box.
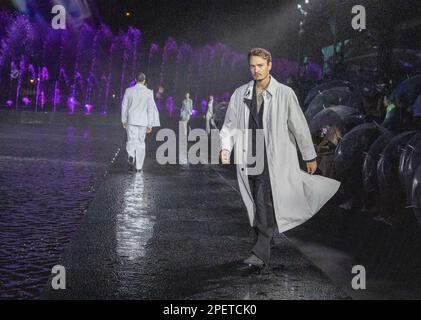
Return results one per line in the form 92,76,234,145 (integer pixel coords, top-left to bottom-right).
121,83,160,128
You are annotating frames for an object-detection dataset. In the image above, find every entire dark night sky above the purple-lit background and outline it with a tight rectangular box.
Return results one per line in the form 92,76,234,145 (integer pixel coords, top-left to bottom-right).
0,0,421,61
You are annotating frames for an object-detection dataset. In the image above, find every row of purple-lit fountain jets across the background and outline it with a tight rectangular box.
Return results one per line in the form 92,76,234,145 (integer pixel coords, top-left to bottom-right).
0,9,321,117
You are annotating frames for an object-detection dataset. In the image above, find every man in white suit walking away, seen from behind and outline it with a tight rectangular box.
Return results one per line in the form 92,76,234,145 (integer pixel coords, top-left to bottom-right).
121,73,160,172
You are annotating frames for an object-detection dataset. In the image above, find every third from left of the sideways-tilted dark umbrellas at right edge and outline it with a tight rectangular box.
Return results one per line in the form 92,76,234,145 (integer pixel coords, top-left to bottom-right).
377,131,417,218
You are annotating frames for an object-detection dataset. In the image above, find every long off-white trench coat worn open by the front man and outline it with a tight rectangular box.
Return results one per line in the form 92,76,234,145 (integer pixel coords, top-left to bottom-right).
220,77,340,233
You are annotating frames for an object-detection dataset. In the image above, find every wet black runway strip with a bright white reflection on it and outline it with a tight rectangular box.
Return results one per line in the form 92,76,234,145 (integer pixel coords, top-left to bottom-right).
43,127,348,299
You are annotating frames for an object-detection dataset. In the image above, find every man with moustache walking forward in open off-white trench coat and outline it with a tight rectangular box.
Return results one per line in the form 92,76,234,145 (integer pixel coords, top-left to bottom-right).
220,48,340,267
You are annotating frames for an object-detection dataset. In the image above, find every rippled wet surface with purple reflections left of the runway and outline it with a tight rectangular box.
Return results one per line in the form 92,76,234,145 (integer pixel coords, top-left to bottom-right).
0,123,120,299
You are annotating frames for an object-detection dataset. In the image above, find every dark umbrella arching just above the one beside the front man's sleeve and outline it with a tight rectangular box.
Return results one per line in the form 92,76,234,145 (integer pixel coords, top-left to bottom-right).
305,87,358,122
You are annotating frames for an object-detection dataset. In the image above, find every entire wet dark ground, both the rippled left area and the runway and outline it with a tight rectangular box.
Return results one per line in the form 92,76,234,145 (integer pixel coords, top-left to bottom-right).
0,120,421,300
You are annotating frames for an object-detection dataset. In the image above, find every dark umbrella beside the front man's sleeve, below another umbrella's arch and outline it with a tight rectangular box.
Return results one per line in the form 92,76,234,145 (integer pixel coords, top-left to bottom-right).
309,106,364,136
